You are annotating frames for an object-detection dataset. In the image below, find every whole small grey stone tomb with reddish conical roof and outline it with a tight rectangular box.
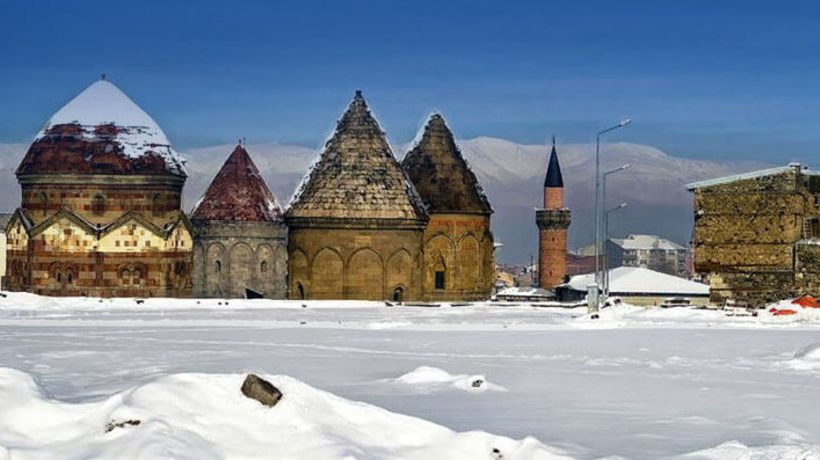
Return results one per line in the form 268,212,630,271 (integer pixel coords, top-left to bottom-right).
191,144,287,299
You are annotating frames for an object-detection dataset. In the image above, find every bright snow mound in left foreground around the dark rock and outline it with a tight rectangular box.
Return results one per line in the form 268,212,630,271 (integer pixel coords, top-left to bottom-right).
0,368,556,460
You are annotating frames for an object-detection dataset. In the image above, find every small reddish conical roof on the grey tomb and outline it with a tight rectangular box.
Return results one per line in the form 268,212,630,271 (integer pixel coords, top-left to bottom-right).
191,144,282,222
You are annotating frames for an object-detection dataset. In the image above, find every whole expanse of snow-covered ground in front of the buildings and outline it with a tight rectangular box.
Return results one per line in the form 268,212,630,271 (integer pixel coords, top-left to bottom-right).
0,294,820,460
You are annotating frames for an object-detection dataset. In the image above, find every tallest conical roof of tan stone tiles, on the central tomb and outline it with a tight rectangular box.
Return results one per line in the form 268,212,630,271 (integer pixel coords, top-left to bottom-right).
287,91,427,221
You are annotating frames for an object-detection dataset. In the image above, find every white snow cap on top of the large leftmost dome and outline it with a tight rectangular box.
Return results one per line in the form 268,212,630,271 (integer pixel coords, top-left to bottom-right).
34,79,185,172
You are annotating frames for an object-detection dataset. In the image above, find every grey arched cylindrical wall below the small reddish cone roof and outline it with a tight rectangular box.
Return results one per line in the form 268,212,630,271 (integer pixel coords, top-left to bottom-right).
193,220,287,299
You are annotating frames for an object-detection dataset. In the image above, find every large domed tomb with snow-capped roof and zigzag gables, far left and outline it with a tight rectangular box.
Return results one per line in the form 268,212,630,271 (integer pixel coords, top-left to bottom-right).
6,79,192,297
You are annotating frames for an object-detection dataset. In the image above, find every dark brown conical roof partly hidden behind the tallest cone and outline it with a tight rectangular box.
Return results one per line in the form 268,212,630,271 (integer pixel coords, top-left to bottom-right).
402,113,493,214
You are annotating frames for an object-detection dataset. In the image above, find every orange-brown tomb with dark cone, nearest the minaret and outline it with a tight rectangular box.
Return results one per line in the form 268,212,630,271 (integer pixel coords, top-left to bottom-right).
402,114,495,300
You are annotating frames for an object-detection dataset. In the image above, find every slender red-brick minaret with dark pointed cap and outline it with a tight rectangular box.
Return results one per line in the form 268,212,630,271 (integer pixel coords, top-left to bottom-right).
535,136,570,289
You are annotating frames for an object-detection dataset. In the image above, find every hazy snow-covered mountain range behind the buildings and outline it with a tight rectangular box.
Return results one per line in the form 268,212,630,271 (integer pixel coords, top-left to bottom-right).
0,137,766,262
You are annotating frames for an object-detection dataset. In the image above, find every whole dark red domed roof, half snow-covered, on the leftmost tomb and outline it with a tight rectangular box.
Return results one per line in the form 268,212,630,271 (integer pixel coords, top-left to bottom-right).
17,77,185,177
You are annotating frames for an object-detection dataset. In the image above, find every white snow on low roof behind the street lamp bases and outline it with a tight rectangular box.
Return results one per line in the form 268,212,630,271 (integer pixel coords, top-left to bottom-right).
567,267,709,296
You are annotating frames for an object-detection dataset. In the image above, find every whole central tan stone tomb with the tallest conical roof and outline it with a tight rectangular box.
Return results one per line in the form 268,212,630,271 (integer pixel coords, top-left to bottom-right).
286,91,428,300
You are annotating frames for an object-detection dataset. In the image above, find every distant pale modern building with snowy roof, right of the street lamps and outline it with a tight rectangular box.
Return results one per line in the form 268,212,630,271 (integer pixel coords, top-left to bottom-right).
605,235,690,277
